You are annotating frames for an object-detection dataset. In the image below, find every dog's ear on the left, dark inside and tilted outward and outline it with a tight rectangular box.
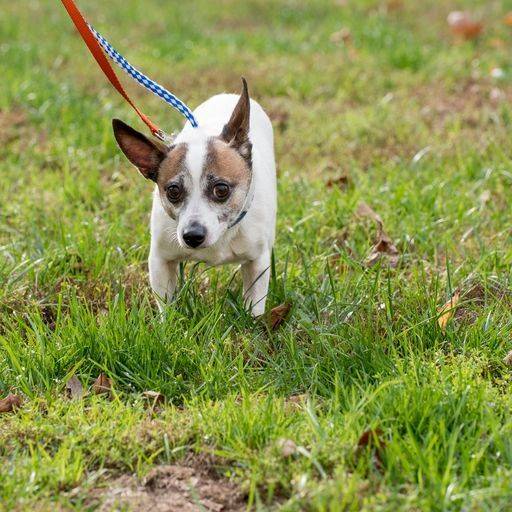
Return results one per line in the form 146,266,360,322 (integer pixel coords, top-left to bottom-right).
112,119,168,181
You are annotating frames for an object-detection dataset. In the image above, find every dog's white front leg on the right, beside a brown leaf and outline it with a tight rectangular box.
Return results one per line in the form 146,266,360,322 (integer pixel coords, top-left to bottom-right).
242,252,270,316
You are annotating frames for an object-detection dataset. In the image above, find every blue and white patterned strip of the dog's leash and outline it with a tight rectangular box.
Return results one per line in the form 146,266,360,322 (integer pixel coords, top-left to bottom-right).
87,23,199,128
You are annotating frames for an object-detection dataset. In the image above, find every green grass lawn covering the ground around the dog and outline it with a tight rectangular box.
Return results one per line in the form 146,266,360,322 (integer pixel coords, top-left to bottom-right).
0,0,512,511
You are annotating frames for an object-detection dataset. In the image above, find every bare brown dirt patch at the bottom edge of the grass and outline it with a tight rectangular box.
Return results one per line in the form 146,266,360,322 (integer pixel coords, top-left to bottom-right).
92,465,246,512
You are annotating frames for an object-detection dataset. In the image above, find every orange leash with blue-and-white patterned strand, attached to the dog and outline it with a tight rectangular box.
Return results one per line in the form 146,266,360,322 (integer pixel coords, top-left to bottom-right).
61,0,198,142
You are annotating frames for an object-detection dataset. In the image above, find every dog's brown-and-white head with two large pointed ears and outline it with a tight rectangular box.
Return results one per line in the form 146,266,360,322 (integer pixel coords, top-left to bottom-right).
113,79,252,248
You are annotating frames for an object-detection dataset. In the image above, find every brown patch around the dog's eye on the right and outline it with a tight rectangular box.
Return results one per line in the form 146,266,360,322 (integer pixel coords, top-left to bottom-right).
201,138,252,222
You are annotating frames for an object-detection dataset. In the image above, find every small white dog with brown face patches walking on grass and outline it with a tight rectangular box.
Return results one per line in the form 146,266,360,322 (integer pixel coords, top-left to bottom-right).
112,78,277,317
